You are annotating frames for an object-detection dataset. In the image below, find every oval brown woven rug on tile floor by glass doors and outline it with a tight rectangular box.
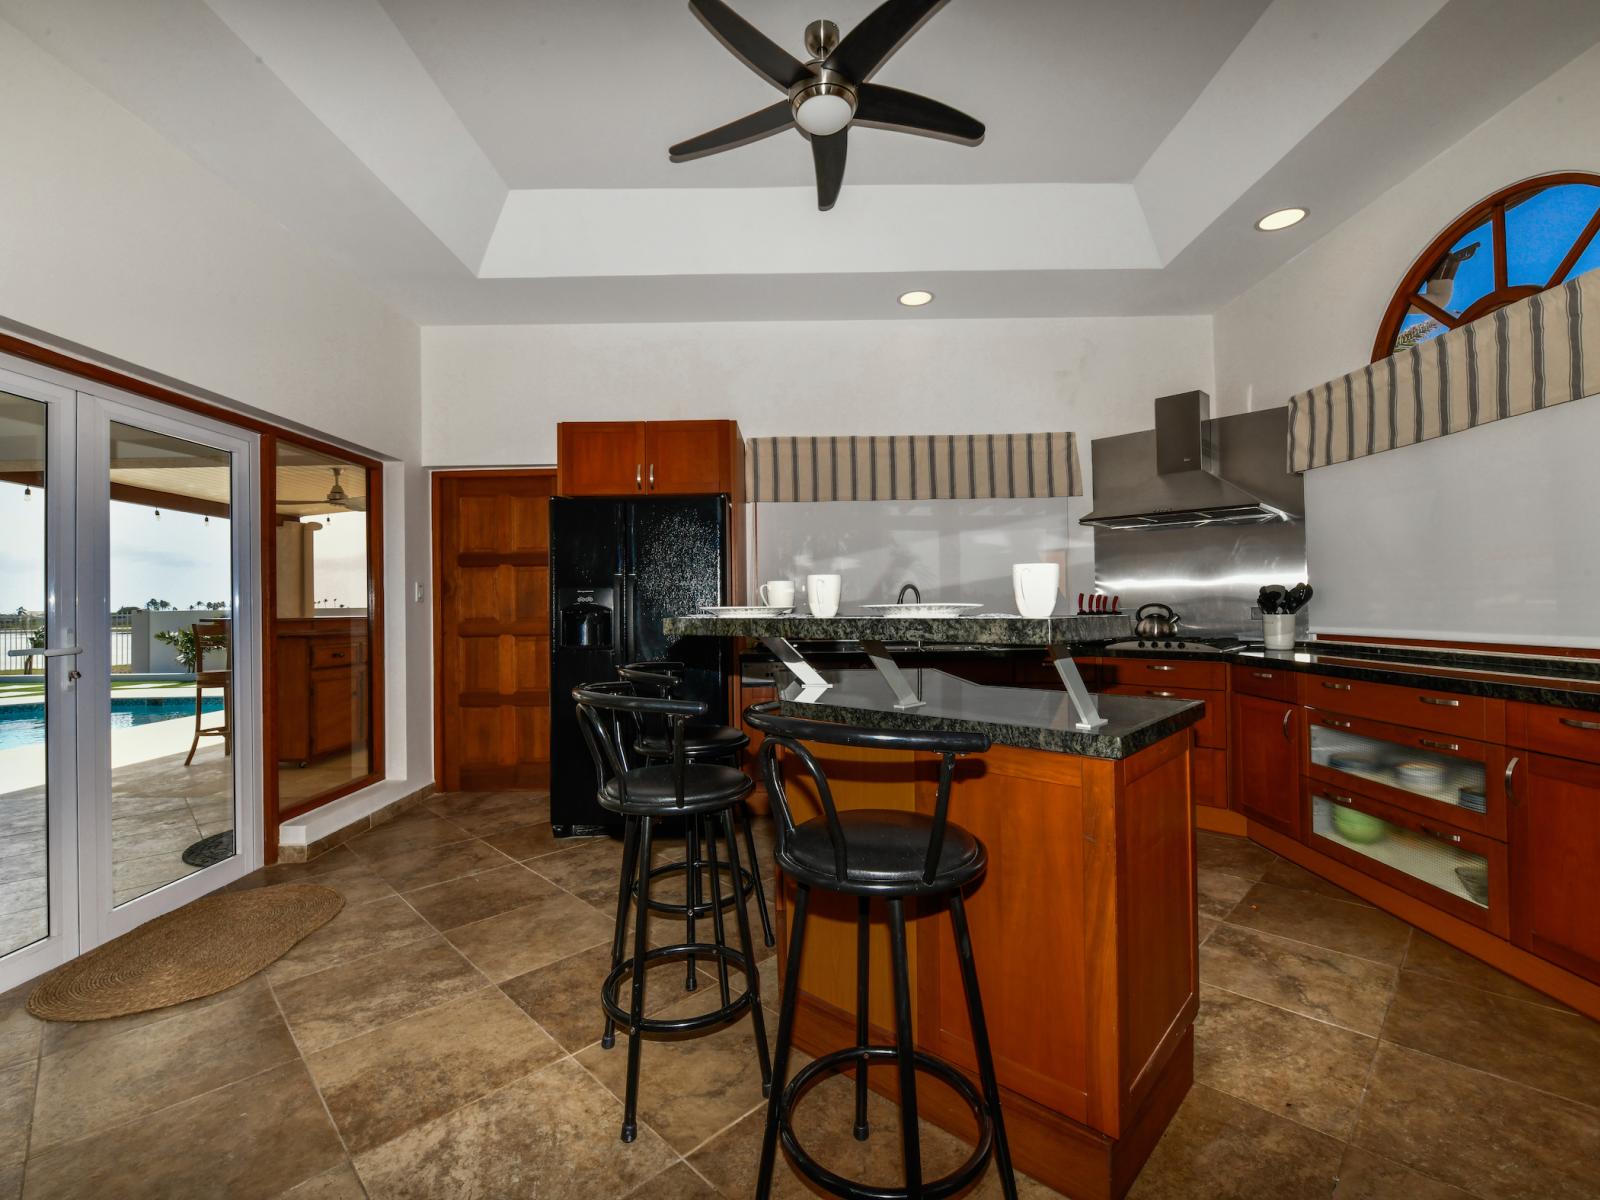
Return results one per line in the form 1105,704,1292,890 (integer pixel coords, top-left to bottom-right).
27,883,344,1021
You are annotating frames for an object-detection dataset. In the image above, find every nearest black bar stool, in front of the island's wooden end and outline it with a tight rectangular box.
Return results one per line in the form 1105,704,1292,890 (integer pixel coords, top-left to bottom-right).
746,701,1016,1200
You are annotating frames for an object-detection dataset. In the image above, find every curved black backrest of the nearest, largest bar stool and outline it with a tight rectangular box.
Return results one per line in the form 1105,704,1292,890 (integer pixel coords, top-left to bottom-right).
744,701,989,883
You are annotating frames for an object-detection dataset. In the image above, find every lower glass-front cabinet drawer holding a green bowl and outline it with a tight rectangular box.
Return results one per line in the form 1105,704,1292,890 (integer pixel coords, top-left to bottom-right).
1304,779,1510,938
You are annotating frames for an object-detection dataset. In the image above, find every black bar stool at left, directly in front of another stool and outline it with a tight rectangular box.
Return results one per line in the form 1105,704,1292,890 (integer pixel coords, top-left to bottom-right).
573,682,771,1142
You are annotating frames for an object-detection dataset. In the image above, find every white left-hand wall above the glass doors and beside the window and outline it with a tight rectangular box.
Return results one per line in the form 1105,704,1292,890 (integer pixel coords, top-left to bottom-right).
0,22,432,803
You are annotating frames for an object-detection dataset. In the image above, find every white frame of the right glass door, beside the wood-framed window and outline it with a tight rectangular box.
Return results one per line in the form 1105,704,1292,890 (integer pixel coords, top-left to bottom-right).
77,387,262,947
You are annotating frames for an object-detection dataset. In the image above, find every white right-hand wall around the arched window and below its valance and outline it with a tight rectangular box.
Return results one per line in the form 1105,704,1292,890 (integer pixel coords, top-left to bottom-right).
1216,48,1600,645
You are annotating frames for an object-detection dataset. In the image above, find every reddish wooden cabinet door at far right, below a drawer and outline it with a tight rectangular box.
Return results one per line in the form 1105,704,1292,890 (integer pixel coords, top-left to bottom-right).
1507,750,1600,982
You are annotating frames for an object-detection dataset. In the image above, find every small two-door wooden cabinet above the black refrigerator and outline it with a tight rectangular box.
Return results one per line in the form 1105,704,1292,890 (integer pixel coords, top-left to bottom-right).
555,421,744,499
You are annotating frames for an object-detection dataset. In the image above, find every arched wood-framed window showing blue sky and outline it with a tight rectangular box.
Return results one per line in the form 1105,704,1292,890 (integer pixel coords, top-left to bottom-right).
1373,171,1600,362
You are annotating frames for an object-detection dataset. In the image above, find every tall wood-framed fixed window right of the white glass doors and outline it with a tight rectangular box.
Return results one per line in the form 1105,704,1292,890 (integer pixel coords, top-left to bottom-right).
267,437,382,821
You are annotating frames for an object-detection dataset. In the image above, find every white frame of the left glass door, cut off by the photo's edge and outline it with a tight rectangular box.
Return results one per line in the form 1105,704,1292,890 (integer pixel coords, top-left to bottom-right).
0,366,80,990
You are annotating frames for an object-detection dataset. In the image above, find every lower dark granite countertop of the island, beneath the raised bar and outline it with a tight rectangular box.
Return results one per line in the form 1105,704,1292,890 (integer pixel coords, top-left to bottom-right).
779,669,1205,758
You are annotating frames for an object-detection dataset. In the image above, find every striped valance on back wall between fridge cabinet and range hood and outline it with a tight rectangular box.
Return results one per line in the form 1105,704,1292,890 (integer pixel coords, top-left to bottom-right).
744,434,1083,502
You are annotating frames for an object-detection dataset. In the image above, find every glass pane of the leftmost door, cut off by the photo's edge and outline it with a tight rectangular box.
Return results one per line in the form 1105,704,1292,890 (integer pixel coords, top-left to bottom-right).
0,392,50,957
